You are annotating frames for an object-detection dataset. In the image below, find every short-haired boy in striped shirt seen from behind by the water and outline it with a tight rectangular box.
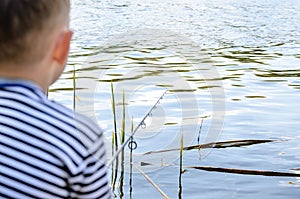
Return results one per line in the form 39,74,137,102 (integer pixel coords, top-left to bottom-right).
0,0,111,199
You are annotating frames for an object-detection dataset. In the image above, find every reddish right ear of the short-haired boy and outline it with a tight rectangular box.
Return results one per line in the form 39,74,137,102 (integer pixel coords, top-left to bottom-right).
53,30,73,65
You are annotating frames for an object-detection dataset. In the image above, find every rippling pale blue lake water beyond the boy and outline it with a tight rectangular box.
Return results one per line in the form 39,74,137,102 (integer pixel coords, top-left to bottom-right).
49,0,300,199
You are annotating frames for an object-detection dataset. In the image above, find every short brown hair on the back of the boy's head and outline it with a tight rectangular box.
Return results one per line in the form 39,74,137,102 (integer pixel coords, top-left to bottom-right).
0,0,70,64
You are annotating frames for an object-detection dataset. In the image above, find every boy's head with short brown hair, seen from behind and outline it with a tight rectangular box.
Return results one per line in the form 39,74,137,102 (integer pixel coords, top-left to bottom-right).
0,0,72,90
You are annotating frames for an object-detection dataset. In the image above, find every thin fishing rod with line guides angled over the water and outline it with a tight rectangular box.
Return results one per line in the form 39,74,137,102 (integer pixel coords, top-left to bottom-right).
106,90,168,167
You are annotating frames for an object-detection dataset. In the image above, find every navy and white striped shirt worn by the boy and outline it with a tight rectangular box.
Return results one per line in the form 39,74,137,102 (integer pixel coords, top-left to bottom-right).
0,79,111,199
